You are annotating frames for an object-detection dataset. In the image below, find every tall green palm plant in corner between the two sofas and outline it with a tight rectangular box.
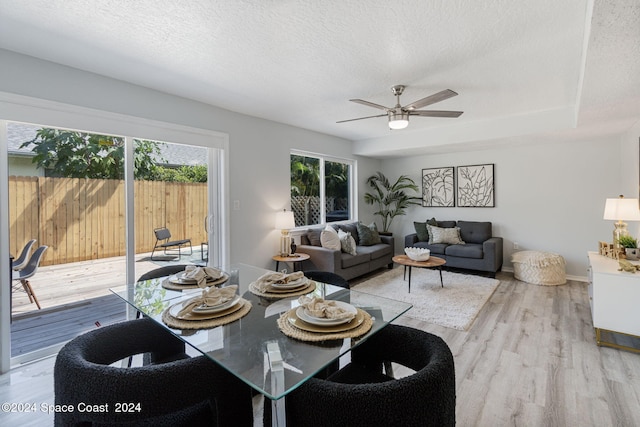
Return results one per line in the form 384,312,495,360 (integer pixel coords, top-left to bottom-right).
364,172,422,234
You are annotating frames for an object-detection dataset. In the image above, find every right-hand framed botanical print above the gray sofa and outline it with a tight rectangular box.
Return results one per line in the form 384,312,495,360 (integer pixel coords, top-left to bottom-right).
456,163,495,208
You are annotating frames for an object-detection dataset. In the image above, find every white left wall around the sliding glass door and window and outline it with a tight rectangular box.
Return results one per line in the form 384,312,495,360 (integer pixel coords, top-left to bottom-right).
0,49,380,268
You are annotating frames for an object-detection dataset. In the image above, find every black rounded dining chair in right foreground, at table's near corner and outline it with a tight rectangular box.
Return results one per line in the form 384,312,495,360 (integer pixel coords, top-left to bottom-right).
263,325,456,427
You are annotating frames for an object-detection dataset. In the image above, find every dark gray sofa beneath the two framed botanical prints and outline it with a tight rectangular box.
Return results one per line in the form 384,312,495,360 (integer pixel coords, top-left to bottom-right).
404,220,503,277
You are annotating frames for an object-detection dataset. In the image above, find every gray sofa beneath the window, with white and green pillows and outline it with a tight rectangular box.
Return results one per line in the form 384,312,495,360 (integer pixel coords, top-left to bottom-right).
297,222,394,280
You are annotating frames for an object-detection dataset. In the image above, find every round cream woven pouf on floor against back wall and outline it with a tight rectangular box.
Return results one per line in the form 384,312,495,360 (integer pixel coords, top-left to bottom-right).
511,251,567,286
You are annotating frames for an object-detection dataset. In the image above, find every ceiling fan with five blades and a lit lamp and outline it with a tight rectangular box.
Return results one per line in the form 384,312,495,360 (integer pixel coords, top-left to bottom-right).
336,85,463,129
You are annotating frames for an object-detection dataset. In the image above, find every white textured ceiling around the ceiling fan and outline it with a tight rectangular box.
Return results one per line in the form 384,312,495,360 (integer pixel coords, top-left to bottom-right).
0,0,640,156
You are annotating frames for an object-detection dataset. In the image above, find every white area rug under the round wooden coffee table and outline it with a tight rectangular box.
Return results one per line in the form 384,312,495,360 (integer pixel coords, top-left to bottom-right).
353,267,500,331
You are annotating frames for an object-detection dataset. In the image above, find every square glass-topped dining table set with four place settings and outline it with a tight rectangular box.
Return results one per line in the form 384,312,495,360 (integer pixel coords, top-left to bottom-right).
111,264,412,426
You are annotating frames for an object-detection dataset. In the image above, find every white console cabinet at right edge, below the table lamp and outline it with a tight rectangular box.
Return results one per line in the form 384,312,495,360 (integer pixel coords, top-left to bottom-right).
588,252,640,352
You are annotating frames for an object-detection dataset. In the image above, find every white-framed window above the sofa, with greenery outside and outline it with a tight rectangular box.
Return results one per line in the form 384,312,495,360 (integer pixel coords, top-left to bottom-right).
291,152,355,227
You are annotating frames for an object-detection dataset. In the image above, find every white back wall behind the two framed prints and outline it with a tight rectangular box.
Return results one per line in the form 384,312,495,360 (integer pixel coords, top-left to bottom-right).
382,134,638,278
